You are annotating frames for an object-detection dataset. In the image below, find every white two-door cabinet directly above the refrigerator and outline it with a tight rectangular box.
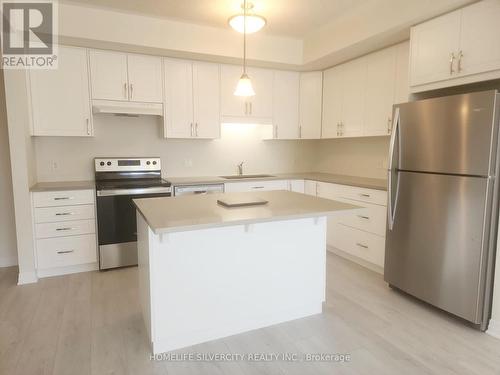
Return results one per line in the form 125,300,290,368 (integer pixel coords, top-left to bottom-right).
410,0,500,92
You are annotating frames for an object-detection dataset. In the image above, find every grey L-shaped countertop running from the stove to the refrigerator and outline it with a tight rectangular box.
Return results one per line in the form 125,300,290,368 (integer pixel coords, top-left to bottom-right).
167,172,387,190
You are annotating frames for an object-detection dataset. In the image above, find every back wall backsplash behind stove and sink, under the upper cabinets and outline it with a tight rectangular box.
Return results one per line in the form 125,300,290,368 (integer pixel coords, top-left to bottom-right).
35,115,314,181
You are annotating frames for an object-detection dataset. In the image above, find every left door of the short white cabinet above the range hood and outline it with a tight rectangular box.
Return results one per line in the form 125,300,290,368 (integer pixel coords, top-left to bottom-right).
90,50,129,100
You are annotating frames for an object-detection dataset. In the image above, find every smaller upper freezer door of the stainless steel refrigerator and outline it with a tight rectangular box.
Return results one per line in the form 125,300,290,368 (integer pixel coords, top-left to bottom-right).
398,91,496,176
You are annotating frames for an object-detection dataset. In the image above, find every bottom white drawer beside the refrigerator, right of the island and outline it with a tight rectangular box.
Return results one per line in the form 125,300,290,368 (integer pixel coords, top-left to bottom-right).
327,223,385,267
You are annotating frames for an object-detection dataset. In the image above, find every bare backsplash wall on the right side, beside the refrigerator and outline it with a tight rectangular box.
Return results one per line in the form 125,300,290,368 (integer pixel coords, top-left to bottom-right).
315,137,389,179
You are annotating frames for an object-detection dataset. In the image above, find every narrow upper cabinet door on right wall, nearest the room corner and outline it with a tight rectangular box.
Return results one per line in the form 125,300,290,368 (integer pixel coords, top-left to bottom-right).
321,65,343,138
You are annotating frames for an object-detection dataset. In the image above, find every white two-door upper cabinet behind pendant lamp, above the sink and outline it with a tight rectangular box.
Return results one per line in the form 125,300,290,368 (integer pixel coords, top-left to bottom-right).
221,65,273,124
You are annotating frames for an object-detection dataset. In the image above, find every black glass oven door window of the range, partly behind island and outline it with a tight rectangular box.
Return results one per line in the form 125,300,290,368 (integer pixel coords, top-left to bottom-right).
97,193,170,245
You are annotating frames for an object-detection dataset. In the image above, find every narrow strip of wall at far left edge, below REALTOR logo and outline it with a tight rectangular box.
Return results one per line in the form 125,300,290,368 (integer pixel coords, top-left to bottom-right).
0,70,17,267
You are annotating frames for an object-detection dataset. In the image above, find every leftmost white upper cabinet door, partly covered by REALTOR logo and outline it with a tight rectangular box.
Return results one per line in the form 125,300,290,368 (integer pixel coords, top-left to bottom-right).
29,46,93,136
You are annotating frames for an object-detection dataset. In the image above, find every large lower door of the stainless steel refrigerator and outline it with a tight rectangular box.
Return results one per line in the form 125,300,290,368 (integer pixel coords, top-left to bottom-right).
384,171,489,324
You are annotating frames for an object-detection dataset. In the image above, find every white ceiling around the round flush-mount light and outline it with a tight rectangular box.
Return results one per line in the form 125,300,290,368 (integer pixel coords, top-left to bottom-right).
62,0,370,39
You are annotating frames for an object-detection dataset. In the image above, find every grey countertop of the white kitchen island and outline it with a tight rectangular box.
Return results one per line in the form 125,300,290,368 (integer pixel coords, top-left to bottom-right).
133,190,361,234
